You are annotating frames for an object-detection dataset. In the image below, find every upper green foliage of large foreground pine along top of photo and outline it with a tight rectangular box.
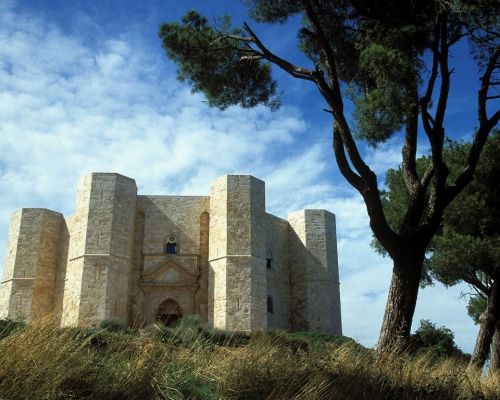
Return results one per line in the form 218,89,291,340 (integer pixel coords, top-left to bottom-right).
160,0,498,145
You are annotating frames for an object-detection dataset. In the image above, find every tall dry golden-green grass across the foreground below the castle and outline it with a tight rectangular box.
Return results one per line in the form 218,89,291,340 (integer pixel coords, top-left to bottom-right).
0,320,500,400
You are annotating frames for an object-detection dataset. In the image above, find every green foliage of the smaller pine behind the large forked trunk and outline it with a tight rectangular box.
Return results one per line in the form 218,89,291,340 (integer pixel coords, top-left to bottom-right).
372,131,500,286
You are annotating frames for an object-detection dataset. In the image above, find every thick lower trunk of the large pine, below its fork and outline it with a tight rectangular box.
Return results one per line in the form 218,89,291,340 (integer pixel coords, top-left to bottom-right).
378,252,425,353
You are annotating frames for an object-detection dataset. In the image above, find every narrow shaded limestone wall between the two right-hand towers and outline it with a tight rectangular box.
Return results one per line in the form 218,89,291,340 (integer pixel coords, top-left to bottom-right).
265,214,291,329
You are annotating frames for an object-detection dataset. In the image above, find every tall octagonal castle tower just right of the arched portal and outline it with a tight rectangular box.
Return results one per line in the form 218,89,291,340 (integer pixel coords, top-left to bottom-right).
209,175,267,331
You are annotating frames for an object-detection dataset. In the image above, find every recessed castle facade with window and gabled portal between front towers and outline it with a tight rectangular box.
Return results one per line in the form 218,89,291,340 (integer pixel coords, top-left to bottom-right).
131,196,209,323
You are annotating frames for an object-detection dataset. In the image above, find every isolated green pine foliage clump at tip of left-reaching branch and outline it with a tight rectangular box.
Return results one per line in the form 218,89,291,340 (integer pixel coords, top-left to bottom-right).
159,11,279,110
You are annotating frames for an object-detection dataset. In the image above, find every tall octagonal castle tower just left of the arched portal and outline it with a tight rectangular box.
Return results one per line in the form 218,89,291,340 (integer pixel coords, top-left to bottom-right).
61,173,137,326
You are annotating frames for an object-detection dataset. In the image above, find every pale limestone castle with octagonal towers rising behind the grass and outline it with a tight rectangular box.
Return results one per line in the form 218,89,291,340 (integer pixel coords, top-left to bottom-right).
0,173,342,334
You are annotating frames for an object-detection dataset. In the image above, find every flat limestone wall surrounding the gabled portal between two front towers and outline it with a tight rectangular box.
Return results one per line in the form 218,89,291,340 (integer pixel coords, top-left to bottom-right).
138,196,210,322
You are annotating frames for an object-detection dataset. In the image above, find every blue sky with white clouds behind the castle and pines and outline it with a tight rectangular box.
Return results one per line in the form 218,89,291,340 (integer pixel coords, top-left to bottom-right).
0,0,486,352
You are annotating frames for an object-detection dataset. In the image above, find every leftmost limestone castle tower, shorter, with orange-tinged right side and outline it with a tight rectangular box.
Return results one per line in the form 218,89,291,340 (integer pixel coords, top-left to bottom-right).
1,208,63,321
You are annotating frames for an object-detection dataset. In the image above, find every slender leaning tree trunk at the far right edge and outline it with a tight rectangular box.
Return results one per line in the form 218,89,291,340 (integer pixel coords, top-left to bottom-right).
469,279,500,370
